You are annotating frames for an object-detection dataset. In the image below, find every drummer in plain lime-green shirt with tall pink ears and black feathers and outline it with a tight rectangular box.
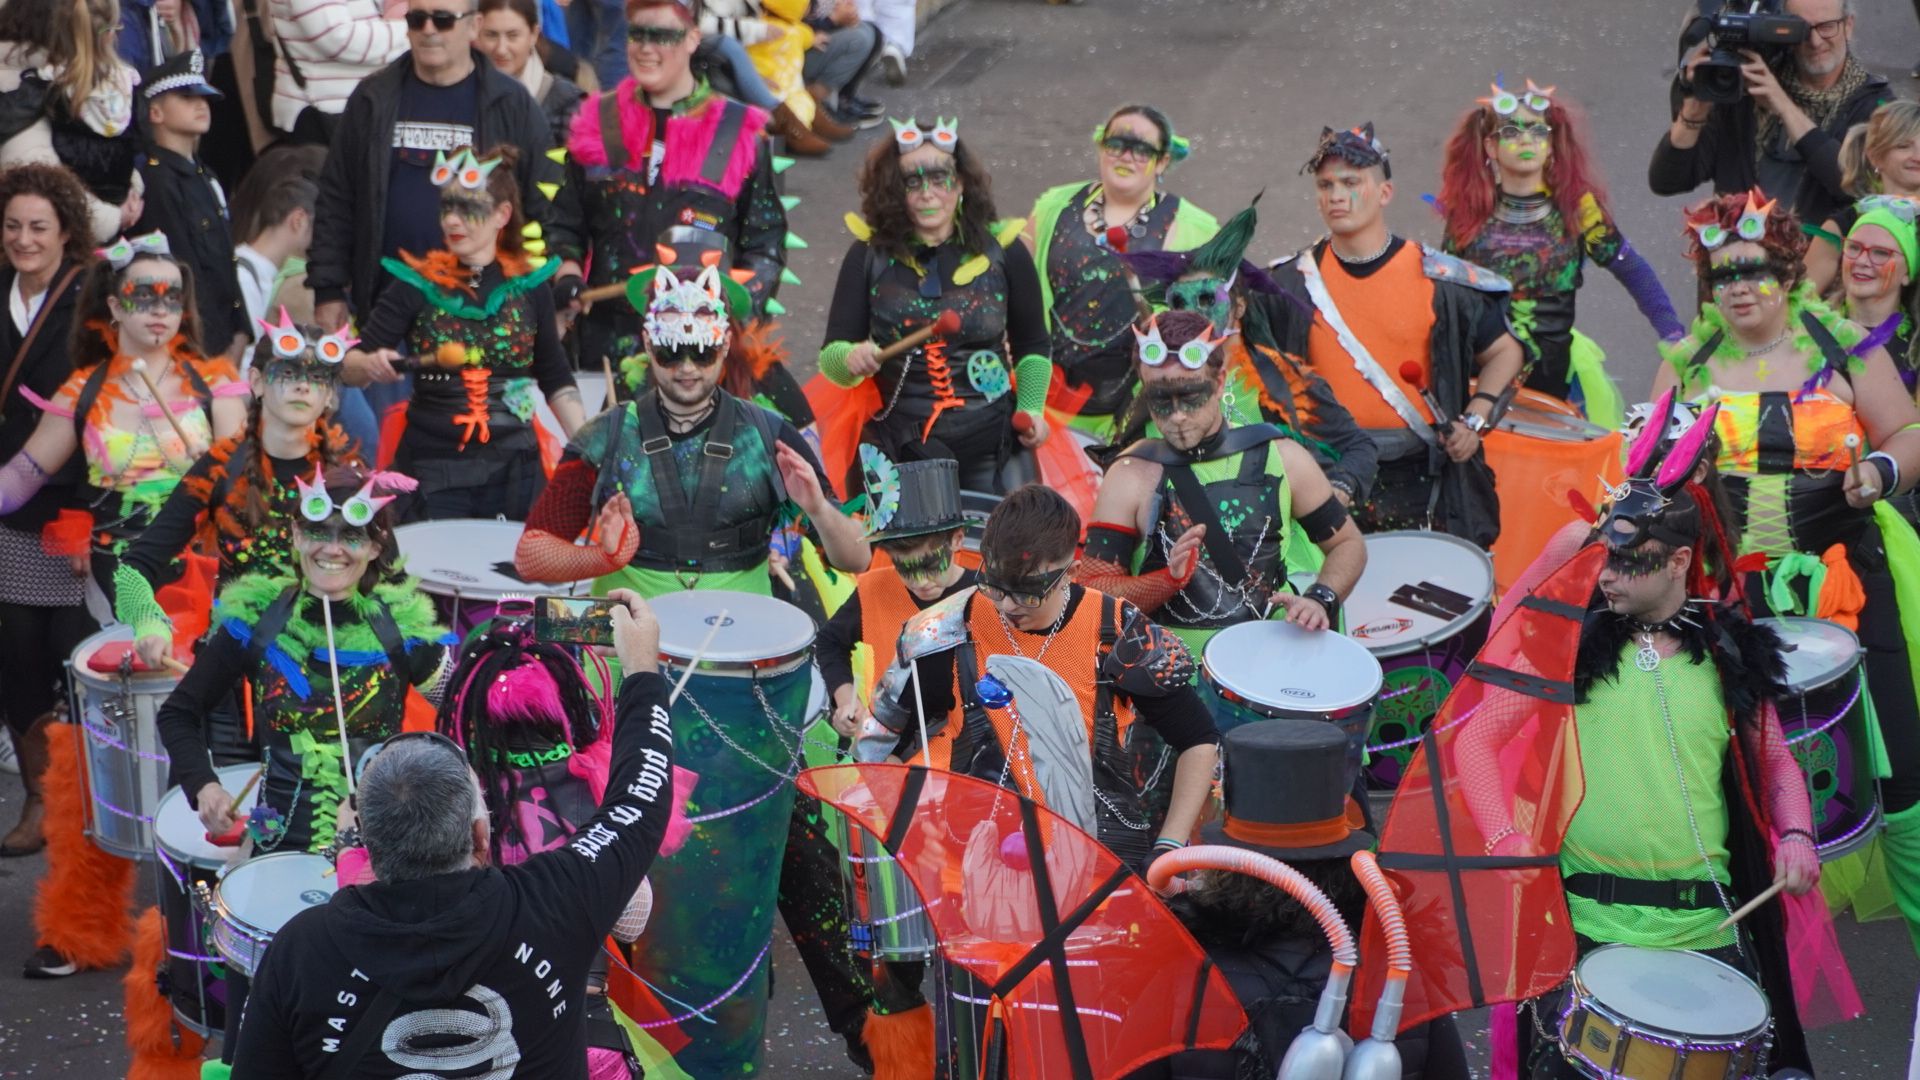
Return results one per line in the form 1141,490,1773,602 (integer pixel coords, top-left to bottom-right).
1457,396,1824,1076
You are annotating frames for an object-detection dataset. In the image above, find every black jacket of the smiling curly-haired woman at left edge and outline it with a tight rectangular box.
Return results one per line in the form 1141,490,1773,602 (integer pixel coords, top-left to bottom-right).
0,263,86,532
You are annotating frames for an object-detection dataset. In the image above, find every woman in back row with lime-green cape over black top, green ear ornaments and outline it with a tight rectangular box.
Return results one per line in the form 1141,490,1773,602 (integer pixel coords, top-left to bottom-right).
1021,104,1219,434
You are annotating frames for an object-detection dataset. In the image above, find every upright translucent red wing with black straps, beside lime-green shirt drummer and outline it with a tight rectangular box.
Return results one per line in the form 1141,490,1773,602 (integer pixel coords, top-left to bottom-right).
1348,544,1607,1032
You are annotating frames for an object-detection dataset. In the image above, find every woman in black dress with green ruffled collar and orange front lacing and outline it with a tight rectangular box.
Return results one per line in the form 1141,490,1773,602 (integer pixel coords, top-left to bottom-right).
348,148,586,521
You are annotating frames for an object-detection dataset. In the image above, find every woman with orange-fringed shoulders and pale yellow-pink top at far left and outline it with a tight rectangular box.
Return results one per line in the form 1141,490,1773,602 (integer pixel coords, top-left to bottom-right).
0,233,248,596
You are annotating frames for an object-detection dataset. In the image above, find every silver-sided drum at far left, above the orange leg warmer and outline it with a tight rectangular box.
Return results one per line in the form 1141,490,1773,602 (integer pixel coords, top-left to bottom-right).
67,626,180,859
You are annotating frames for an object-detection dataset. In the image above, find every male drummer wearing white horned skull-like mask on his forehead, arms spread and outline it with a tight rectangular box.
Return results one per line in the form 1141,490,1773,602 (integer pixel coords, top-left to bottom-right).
515,247,872,598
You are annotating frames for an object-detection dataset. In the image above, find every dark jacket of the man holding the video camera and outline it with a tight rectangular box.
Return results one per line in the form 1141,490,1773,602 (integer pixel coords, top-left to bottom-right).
1647,75,1893,225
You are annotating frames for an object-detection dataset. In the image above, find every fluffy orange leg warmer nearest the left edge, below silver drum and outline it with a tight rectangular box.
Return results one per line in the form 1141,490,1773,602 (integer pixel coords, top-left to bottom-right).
33,724,132,969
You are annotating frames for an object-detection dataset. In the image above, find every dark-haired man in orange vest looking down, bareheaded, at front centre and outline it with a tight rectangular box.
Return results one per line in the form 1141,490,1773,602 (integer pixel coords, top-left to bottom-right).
856,484,1219,867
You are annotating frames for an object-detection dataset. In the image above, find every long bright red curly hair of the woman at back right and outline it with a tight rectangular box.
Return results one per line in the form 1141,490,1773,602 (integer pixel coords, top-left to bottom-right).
1440,89,1613,248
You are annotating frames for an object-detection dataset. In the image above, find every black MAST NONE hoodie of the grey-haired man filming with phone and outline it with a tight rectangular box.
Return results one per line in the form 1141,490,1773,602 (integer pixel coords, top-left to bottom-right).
234,673,674,1080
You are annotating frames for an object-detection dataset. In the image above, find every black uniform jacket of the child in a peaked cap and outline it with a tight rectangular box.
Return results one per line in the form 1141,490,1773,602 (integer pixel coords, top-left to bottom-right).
127,144,253,356
